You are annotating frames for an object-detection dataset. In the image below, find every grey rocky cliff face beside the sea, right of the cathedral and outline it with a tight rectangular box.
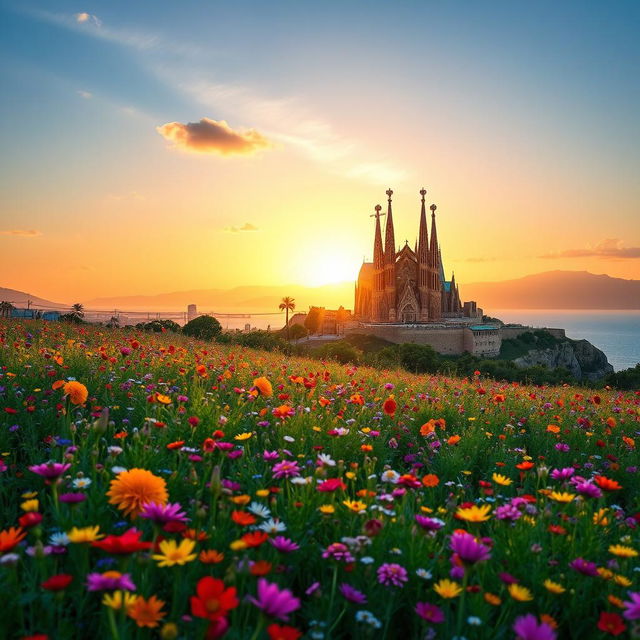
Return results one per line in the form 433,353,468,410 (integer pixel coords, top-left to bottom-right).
513,338,613,380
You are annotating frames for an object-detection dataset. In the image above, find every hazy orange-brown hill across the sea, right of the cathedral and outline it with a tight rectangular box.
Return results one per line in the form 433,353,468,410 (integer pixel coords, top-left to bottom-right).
460,271,640,315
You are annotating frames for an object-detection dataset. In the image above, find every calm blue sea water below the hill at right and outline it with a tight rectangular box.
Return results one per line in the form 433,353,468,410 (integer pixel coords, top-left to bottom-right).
490,309,640,371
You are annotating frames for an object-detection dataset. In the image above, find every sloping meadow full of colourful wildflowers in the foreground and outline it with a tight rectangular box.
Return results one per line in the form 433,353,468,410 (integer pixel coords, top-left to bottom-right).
0,320,640,640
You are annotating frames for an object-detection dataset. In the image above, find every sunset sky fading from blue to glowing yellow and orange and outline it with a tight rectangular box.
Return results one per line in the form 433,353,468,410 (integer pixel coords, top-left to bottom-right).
0,0,640,301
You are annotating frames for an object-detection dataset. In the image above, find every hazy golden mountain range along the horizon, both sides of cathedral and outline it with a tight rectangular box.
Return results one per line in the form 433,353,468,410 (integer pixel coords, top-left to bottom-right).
0,271,640,315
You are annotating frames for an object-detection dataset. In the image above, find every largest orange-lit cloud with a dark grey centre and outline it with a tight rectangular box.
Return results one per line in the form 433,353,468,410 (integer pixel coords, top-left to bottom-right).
156,118,273,156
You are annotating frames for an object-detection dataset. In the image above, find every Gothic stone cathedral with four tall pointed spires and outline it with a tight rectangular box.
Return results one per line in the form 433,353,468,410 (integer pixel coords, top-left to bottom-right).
354,189,466,324
